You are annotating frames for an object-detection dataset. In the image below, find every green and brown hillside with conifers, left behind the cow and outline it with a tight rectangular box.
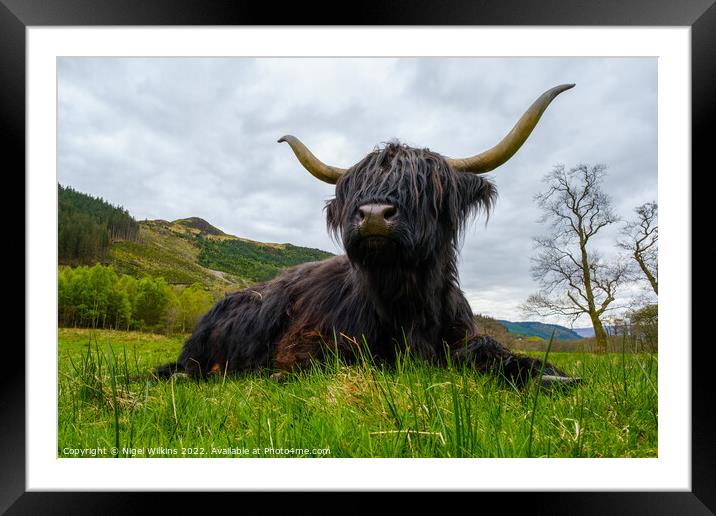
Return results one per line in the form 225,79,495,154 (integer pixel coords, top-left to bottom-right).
58,185,333,295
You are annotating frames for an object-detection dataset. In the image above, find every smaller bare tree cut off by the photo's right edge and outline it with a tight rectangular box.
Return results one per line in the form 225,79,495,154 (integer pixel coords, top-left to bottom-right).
617,202,659,295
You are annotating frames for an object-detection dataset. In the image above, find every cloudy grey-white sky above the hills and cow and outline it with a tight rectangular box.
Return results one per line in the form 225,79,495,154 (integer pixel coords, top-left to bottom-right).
58,58,657,326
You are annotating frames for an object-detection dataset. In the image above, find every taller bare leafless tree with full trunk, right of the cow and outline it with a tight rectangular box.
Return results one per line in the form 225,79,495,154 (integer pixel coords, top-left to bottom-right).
522,165,627,351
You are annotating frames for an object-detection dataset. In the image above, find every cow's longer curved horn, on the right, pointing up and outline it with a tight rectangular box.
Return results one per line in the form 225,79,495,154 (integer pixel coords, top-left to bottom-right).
447,84,574,174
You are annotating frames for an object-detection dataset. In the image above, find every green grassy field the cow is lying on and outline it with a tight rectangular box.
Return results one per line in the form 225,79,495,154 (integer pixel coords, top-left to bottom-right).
58,329,658,458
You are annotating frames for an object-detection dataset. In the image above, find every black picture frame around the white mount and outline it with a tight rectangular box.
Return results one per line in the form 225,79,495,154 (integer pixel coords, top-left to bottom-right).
7,0,716,514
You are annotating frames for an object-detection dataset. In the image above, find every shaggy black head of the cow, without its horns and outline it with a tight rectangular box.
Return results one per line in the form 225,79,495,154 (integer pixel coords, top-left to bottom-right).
326,143,496,268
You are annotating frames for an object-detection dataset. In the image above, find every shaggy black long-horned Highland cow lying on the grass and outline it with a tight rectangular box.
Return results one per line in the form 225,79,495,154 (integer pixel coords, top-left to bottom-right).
155,84,574,385
